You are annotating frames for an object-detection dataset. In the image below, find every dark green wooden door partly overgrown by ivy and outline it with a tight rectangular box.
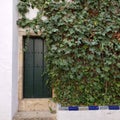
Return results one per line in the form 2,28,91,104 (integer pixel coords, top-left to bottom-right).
23,37,51,98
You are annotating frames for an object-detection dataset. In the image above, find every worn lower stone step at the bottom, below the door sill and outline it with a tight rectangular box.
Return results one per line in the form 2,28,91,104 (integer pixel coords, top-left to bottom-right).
13,111,56,120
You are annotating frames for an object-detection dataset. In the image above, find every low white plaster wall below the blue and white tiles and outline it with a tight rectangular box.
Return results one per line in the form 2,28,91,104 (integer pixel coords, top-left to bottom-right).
57,110,120,120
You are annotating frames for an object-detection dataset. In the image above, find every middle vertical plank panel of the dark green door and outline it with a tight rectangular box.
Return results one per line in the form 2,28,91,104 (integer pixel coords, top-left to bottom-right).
34,39,43,98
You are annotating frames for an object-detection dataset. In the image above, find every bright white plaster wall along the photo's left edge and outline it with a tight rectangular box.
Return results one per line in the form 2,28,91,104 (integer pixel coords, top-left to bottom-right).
0,0,17,120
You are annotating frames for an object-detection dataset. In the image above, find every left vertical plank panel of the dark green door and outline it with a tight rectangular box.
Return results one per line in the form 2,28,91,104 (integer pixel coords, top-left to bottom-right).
23,39,33,98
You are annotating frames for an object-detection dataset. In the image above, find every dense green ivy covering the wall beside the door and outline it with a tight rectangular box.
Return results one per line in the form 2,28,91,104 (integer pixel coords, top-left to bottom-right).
18,0,120,105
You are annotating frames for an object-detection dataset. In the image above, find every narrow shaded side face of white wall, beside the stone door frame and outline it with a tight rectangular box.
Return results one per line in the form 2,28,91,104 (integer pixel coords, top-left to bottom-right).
12,0,18,116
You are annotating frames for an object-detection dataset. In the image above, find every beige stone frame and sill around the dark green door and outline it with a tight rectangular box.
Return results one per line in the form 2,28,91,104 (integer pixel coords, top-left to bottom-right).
18,28,56,111
